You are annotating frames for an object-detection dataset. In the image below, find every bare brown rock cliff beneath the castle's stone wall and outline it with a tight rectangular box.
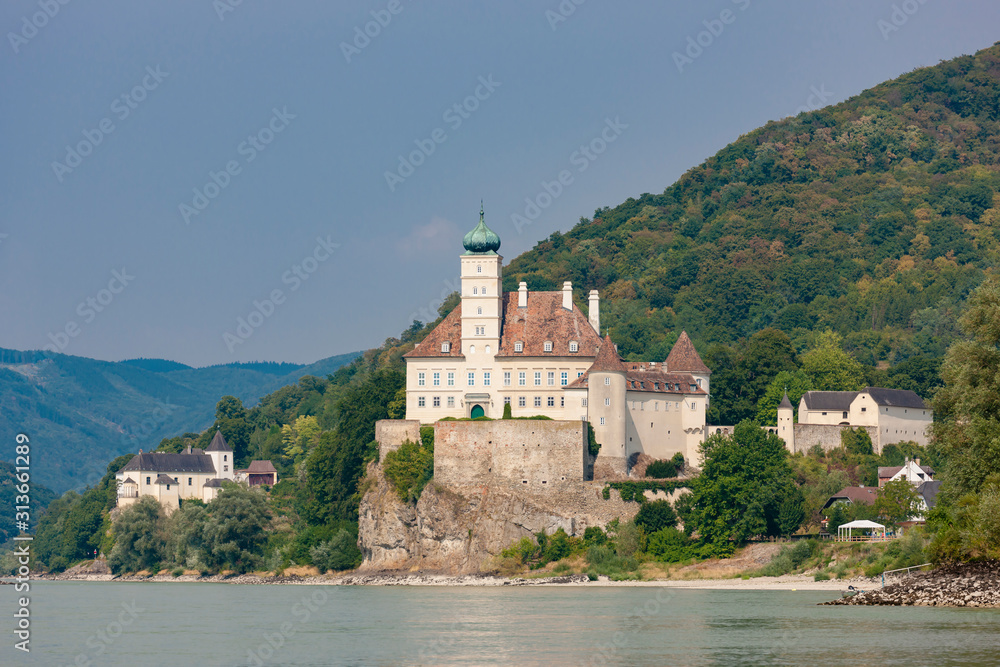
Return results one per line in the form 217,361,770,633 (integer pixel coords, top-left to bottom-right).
358,462,639,575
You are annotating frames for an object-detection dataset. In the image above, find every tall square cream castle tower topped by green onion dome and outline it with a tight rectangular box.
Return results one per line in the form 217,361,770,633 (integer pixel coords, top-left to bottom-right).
461,206,503,417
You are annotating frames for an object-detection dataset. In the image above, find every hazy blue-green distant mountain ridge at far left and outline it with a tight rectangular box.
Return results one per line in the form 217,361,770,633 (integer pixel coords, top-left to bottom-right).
0,348,361,493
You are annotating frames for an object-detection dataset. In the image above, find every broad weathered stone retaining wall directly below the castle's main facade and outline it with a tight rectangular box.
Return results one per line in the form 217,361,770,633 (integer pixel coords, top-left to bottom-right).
436,419,587,490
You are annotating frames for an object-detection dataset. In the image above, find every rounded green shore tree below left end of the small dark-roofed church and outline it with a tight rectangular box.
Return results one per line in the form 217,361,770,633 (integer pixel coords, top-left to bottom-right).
108,496,166,574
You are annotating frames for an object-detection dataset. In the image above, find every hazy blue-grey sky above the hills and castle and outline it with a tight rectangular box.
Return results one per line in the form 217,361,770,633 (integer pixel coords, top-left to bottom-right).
0,0,1000,365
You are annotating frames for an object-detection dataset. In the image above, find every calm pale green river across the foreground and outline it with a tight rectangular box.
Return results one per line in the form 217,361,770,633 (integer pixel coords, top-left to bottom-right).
7,582,1000,667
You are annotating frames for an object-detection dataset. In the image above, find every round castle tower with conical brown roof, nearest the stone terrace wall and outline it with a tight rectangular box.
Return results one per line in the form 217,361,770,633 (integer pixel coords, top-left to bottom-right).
587,336,629,479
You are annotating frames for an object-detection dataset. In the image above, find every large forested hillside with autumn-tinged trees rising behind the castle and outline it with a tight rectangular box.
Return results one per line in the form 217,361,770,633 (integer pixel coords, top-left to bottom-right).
504,46,1000,378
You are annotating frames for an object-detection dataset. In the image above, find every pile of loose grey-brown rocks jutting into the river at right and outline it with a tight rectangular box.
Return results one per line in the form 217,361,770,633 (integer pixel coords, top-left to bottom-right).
824,561,1000,608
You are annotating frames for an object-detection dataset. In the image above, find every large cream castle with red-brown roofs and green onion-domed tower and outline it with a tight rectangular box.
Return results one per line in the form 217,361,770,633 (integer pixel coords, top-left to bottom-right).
405,210,711,472
